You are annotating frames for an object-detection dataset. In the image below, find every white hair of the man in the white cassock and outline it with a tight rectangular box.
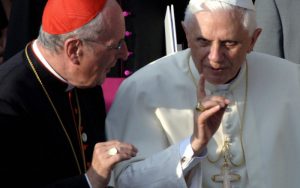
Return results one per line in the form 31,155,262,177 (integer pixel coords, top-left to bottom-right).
183,0,257,36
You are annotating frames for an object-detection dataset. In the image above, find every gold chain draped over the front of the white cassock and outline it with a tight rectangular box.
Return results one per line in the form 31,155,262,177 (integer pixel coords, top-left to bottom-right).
188,61,248,167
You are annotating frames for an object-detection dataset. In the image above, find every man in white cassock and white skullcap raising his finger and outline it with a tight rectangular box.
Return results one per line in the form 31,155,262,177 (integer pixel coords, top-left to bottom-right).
106,0,300,188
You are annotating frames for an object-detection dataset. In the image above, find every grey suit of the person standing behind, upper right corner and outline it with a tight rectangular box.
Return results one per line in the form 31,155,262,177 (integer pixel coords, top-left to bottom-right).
254,0,300,64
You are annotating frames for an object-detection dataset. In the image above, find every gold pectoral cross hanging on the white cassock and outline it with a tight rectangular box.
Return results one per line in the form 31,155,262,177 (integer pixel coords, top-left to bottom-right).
211,138,241,188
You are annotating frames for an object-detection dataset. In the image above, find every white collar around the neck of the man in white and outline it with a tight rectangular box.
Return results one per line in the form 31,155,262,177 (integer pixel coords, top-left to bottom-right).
189,57,245,92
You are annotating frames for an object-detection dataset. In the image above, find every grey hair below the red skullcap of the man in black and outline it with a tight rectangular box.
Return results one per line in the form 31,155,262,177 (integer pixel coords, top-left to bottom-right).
37,11,105,53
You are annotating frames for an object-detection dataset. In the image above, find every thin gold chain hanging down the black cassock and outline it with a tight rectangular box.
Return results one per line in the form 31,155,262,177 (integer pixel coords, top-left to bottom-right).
25,44,86,174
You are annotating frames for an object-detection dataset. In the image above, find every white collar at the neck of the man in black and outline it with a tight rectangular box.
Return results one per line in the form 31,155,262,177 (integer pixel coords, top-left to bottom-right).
32,40,74,91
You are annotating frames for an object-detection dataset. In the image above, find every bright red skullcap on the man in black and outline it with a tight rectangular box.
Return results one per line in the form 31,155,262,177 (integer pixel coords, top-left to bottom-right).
42,0,106,34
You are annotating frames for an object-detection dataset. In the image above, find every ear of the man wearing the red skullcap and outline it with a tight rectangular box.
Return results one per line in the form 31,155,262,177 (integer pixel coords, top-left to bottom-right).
64,38,82,64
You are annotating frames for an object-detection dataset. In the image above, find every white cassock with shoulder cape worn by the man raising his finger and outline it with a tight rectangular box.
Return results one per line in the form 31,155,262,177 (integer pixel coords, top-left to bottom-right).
106,49,300,188
